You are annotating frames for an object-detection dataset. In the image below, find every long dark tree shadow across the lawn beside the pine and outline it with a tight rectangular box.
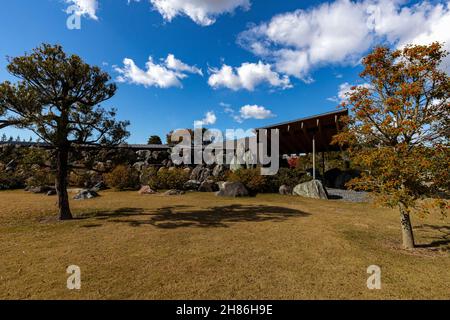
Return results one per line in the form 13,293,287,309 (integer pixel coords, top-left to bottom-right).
80,205,309,229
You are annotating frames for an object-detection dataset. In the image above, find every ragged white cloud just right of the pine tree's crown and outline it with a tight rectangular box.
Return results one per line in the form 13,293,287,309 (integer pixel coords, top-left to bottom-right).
115,54,202,88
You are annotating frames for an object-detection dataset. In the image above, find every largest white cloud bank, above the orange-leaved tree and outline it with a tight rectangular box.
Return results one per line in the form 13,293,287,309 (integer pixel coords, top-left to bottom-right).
238,0,450,82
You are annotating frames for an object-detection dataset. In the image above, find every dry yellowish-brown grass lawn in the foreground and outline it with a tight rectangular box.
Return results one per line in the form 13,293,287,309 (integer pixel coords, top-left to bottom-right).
0,191,450,299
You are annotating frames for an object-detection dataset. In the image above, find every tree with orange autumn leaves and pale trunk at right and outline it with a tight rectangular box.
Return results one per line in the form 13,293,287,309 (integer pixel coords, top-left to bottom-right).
335,43,450,248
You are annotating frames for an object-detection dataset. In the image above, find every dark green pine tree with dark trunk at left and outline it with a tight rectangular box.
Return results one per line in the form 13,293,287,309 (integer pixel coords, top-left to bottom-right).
0,44,128,220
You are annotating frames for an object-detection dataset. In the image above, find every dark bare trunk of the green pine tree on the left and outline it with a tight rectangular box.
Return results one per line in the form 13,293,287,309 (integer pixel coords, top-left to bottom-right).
56,147,73,220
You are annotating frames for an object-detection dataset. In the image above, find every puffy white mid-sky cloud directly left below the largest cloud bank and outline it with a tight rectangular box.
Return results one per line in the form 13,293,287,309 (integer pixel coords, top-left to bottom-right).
208,61,291,91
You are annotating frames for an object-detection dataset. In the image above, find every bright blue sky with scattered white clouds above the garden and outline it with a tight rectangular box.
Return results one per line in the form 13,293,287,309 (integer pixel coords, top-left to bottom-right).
0,0,450,143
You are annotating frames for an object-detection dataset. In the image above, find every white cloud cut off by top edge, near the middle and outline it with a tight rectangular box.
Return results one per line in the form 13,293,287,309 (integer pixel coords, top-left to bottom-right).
148,0,250,26
